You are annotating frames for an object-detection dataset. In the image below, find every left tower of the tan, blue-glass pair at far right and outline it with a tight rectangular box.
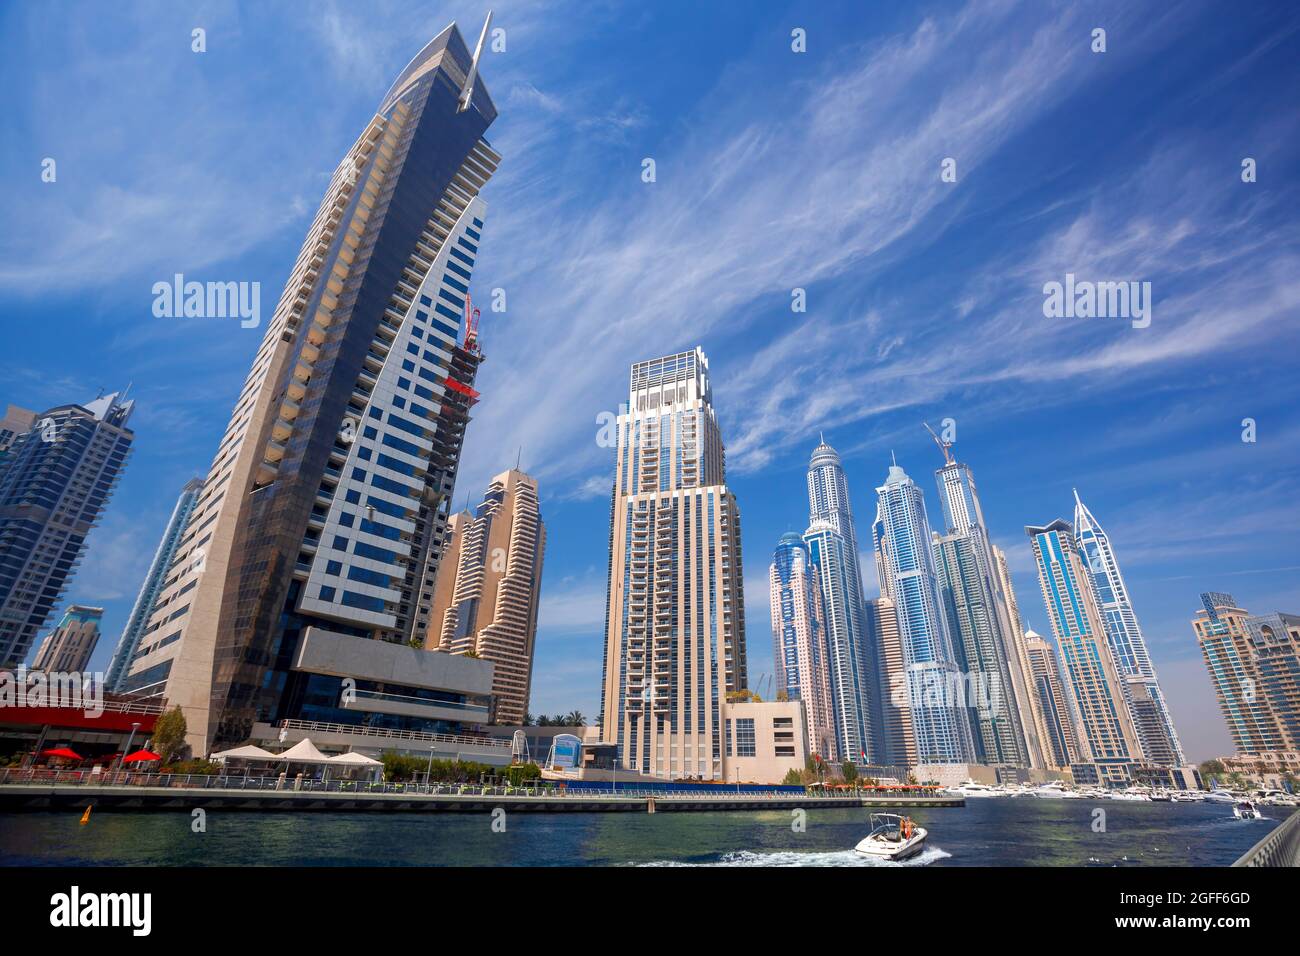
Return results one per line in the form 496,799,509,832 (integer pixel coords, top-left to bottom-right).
1192,592,1294,753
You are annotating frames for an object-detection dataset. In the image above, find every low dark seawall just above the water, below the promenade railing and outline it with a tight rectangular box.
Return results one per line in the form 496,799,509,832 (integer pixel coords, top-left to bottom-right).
0,784,966,813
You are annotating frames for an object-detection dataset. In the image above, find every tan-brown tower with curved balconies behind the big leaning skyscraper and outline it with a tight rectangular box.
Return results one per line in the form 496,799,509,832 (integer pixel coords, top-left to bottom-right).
424,468,546,723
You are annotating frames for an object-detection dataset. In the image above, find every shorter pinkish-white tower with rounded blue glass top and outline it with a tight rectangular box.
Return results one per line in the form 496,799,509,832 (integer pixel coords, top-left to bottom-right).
768,531,840,761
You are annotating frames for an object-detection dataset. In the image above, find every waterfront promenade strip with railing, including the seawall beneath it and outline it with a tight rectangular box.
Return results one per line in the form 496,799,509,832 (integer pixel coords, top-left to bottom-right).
0,770,966,813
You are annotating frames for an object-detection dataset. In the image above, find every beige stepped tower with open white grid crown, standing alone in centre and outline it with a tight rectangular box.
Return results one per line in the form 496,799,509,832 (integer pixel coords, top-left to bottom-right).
601,349,748,779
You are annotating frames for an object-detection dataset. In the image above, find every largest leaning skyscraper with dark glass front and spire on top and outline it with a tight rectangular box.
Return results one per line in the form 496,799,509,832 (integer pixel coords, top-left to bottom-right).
127,25,499,753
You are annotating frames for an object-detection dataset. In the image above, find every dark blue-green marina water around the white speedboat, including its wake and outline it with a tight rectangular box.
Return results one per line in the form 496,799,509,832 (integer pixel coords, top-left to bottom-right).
0,797,1279,866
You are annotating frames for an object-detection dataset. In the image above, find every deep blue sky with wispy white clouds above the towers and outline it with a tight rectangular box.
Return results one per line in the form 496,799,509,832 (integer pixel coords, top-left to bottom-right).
0,0,1300,758
